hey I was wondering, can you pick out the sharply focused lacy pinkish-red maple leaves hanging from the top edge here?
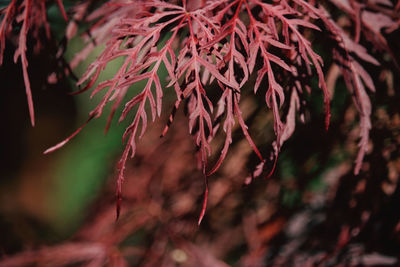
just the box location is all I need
[0,0,400,223]
